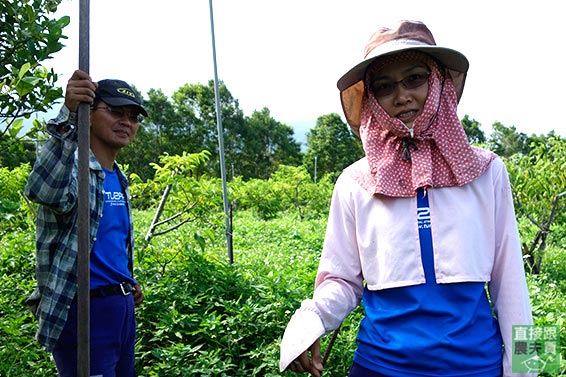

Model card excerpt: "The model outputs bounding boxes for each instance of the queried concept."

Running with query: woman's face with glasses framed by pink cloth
[370,60,430,128]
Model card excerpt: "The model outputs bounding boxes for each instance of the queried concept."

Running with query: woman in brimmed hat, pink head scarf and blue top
[280,21,532,377]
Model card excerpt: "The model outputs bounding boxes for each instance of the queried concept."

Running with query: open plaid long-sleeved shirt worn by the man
[25,106,134,352]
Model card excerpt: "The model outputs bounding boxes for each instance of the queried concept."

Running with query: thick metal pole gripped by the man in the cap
[77,0,90,377]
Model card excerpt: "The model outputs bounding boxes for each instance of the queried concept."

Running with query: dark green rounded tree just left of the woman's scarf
[303,113,364,178]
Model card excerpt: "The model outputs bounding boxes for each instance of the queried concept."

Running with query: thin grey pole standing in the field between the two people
[208,0,234,264]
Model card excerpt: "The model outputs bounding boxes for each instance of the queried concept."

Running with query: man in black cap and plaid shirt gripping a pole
[25,70,147,377]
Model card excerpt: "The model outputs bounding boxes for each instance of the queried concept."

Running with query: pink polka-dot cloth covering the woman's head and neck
[350,51,496,197]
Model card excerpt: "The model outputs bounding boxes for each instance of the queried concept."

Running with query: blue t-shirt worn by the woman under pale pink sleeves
[354,189,502,377]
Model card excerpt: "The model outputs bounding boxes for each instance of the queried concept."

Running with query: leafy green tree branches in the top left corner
[0,0,70,165]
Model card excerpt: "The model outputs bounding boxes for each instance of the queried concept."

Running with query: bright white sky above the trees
[43,0,566,141]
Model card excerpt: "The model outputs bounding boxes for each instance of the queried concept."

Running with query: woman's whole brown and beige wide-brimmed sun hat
[337,21,469,135]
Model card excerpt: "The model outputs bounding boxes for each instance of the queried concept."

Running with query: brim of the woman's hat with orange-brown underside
[337,43,469,135]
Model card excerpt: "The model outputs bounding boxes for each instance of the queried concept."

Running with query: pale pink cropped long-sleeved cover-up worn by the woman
[281,155,532,376]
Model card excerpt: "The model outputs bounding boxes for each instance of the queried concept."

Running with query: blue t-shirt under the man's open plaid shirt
[90,169,135,289]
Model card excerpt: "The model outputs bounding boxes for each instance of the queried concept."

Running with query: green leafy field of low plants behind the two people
[0,207,566,377]
